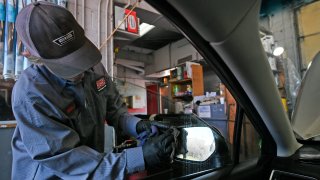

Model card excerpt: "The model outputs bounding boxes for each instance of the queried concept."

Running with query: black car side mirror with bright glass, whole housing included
[150,114,231,171]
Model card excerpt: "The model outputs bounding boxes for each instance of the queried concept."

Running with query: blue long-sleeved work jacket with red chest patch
[12,63,144,180]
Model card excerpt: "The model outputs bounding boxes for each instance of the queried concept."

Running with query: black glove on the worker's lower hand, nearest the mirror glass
[142,130,174,168]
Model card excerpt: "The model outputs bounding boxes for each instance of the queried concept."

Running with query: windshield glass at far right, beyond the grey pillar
[260,1,320,140]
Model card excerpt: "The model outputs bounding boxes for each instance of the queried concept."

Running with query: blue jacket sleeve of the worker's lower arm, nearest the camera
[13,101,144,179]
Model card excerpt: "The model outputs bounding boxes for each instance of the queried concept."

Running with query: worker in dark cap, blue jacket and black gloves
[12,1,174,180]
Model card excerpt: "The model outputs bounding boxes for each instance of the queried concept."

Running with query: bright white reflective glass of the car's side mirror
[176,127,215,161]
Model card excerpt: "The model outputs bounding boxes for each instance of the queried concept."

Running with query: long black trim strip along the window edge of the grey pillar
[146,0,276,156]
